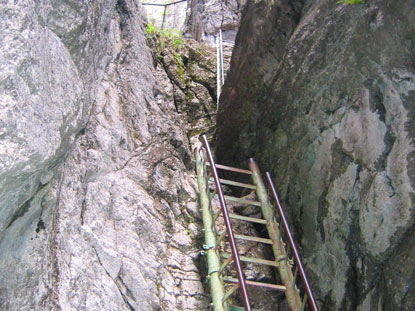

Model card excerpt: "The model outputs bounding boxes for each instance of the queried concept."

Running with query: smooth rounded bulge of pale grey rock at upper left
[0,2,85,238]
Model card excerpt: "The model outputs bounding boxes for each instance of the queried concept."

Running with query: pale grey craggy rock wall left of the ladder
[0,0,207,310]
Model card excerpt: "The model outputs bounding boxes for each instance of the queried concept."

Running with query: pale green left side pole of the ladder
[195,149,228,311]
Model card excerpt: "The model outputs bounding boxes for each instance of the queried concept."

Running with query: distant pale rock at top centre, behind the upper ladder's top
[184,0,247,43]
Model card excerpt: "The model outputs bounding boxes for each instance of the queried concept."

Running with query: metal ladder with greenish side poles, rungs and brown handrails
[195,135,318,311]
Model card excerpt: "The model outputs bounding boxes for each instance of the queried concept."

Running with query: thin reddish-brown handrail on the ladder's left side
[202,135,252,311]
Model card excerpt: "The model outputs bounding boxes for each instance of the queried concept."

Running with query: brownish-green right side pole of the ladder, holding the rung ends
[249,159,301,311]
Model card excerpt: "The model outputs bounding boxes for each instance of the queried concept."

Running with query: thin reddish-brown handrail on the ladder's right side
[266,172,318,311]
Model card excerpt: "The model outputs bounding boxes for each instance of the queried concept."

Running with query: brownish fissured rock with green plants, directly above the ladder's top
[148,28,226,142]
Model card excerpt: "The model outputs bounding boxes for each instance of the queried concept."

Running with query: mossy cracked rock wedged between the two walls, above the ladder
[153,39,217,132]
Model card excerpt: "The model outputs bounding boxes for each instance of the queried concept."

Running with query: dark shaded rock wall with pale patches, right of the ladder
[216,0,415,311]
